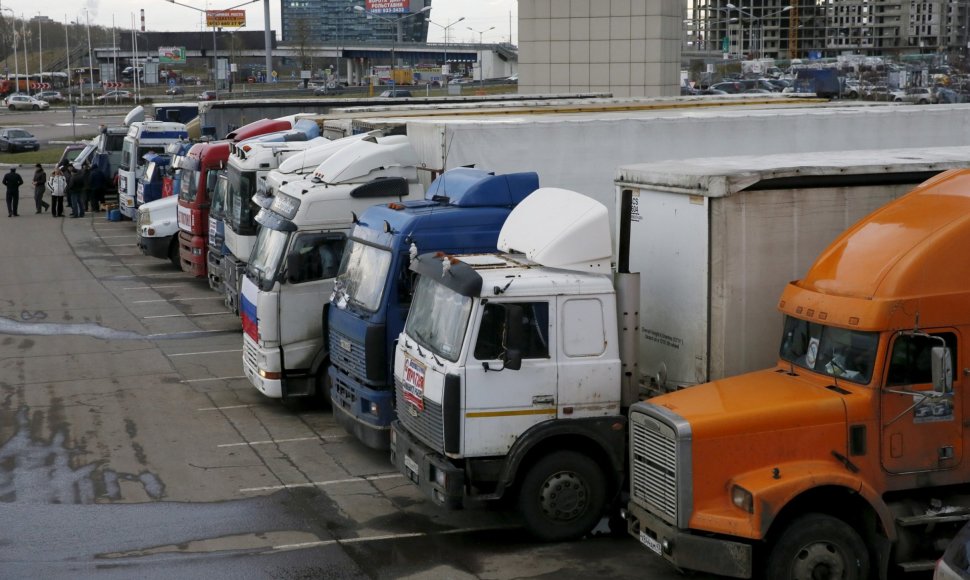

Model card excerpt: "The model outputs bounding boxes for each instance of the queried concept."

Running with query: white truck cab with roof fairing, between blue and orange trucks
[391,188,625,540]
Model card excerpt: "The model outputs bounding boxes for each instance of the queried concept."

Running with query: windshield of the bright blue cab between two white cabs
[334,239,391,312]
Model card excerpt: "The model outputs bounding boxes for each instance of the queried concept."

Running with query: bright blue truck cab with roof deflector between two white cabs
[324,168,539,449]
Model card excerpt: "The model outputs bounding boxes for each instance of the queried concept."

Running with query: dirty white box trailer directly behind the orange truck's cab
[616,147,970,391]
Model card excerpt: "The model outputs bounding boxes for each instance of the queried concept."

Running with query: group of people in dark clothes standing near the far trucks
[3,163,108,218]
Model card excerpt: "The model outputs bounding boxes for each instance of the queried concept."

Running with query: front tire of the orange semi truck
[765,514,869,580]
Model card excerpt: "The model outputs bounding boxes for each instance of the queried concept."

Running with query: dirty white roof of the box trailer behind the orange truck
[615,147,970,197]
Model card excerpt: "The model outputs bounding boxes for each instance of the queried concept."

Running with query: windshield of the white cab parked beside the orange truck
[404,276,472,362]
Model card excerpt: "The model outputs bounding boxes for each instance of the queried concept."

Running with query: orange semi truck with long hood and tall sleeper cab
[626,170,970,580]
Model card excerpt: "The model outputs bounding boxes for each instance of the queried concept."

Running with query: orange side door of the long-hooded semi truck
[881,330,963,473]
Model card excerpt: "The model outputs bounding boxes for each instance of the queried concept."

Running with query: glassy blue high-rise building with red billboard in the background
[280,0,431,44]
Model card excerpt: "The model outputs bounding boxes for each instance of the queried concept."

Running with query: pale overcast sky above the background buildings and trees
[0,0,518,42]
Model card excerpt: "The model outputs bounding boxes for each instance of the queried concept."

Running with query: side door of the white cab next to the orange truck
[462,301,558,456]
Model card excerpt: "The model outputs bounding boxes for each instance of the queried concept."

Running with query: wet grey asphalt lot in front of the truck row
[0,198,702,580]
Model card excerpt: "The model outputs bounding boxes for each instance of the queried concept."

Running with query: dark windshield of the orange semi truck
[780,316,879,384]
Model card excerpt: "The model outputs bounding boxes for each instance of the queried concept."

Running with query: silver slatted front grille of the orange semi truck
[630,414,678,525]
